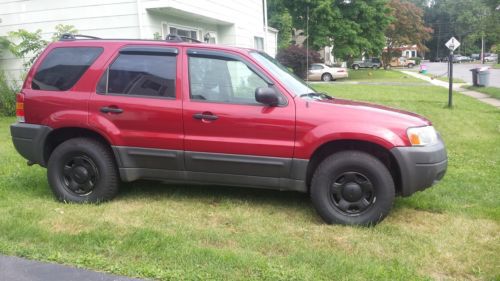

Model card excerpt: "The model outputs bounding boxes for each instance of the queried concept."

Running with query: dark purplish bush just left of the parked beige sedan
[276,45,321,78]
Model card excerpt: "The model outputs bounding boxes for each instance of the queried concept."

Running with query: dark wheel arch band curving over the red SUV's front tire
[306,139,402,194]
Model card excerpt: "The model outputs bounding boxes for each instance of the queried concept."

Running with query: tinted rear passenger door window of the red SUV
[97,53,177,98]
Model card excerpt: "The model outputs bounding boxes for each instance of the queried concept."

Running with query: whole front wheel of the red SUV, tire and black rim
[310,151,395,226]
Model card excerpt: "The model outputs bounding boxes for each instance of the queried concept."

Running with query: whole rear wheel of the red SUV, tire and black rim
[47,138,119,203]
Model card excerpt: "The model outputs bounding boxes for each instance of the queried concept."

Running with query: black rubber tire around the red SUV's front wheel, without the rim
[311,151,395,226]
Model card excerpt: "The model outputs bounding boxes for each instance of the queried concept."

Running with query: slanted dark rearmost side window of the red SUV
[31,47,102,91]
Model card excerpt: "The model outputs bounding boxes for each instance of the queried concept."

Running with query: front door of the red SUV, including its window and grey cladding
[183,50,295,177]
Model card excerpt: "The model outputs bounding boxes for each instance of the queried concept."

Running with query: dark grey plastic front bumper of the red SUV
[391,138,448,196]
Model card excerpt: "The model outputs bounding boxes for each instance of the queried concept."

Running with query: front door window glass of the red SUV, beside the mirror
[189,57,268,104]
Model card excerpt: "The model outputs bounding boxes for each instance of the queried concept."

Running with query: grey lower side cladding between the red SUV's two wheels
[113,146,308,192]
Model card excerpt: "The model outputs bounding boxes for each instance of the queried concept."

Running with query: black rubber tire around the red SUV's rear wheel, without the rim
[47,139,117,203]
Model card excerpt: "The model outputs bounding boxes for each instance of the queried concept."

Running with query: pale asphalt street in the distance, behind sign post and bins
[415,62,500,88]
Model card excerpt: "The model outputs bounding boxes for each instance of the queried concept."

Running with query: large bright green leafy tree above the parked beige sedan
[283,0,391,59]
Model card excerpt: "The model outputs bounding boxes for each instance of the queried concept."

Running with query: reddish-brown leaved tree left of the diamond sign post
[383,0,432,65]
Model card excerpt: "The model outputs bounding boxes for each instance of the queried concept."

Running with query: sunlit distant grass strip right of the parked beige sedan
[348,69,425,83]
